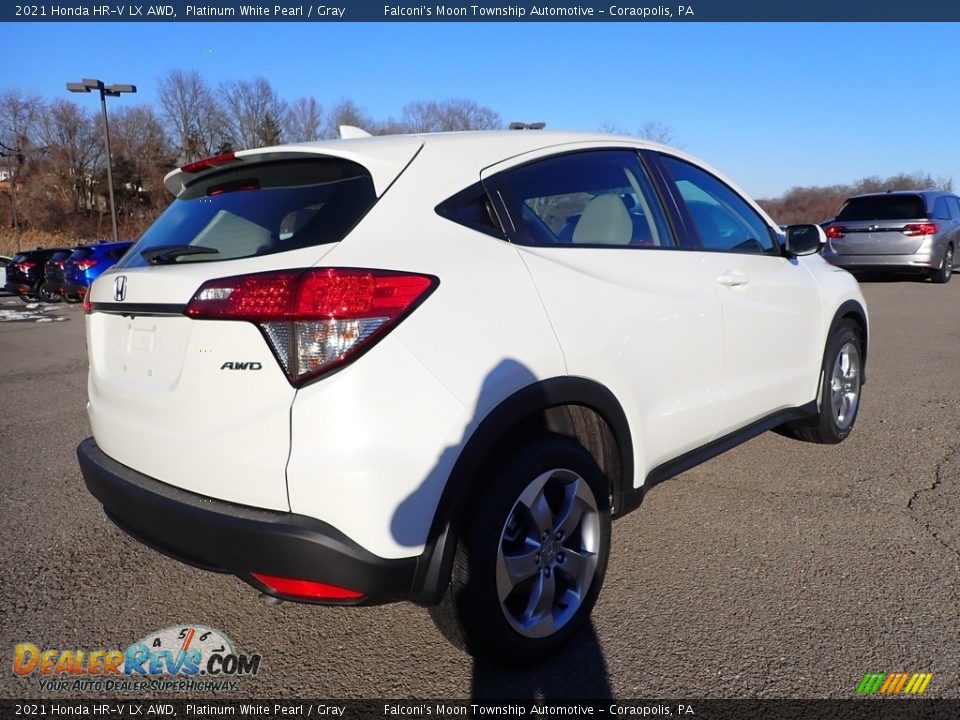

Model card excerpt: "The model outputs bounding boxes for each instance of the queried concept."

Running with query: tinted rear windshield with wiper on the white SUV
[118,158,377,267]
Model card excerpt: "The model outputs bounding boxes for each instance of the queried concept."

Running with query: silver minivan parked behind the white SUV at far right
[823,190,960,283]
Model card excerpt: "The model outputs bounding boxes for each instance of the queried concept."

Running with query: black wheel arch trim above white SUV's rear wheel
[411,377,636,605]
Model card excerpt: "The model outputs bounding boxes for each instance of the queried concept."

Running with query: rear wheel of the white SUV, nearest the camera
[430,435,610,665]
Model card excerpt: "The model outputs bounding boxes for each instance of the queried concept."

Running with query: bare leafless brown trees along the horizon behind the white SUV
[0,75,952,255]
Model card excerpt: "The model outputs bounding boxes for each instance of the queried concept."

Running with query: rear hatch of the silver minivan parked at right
[826,193,931,255]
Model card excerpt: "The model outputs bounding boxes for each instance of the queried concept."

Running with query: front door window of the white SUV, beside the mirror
[661,155,777,255]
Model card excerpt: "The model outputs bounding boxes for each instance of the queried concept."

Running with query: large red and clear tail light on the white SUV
[185,268,438,386]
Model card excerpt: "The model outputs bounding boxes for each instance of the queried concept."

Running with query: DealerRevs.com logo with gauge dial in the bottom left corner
[13,625,262,692]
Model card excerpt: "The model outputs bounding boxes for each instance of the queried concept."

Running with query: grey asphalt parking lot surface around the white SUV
[0,280,960,699]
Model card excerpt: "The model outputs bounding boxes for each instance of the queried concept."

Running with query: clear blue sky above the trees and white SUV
[0,22,960,197]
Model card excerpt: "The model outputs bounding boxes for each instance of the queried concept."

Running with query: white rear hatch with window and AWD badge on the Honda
[87,139,419,510]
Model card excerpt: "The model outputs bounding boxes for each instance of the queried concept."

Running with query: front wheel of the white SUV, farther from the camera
[784,320,863,445]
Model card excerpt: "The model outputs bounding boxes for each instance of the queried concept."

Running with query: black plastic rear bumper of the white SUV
[77,438,417,605]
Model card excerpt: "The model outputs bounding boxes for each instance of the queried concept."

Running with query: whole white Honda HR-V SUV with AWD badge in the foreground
[78,131,868,661]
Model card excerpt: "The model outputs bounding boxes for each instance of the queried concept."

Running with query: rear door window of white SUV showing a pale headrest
[497,150,676,248]
